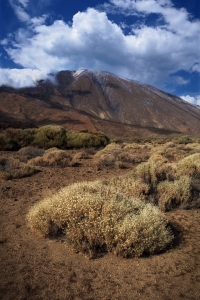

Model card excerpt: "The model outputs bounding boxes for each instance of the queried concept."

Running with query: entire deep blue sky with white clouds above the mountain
[0,0,200,105]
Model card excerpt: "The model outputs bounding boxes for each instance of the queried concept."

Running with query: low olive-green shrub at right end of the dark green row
[66,132,109,148]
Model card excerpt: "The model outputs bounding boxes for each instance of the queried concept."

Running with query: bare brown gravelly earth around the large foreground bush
[0,151,200,300]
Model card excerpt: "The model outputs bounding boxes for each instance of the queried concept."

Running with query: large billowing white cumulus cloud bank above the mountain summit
[0,0,200,105]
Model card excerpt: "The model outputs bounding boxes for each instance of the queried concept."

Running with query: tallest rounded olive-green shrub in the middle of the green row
[32,125,66,149]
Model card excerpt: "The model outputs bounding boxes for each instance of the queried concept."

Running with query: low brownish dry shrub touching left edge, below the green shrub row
[0,157,38,179]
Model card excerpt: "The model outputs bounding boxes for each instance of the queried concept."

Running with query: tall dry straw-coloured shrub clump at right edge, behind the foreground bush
[133,153,200,211]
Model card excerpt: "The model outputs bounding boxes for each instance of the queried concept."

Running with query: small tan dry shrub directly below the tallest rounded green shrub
[28,150,72,168]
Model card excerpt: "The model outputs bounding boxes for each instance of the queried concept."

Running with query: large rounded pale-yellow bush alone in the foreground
[28,181,173,257]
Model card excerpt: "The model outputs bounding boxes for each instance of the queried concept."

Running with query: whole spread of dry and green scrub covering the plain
[0,126,200,257]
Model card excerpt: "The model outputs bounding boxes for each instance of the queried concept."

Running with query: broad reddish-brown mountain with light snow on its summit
[0,70,200,136]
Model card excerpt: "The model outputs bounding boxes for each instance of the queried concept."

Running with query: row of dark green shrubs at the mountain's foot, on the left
[0,125,109,151]
